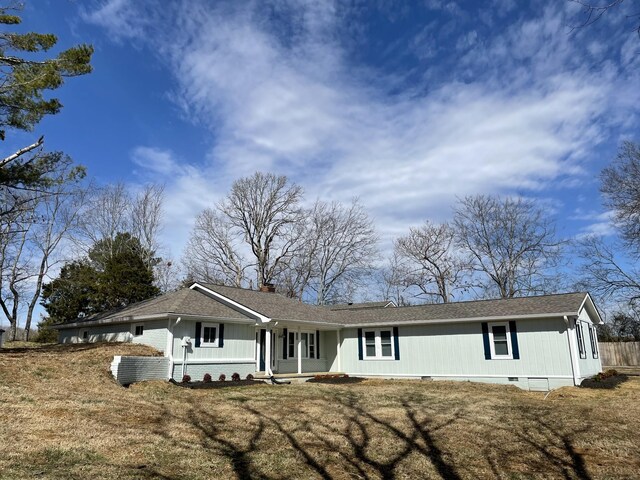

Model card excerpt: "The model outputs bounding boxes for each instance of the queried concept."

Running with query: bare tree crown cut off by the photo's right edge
[600,142,640,256]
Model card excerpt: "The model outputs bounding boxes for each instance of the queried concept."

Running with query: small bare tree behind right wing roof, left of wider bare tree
[394,221,470,303]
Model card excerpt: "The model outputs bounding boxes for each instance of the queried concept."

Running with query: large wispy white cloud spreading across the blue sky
[81,0,636,258]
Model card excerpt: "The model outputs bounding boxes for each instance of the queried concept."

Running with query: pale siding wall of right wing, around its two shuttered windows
[341,318,573,389]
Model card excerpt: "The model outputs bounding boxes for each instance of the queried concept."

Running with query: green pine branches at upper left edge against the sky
[0,7,93,219]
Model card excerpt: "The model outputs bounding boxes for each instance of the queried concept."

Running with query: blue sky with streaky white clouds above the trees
[15,0,640,258]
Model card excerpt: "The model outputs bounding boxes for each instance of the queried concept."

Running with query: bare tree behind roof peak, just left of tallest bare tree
[183,208,251,287]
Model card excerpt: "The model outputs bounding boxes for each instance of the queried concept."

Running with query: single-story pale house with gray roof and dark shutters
[56,283,601,390]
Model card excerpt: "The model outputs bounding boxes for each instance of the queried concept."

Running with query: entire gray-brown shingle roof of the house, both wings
[63,284,587,326]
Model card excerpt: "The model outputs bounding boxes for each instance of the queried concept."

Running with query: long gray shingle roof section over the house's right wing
[340,293,587,325]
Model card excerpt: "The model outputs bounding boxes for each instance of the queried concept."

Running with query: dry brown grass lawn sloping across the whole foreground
[0,344,640,480]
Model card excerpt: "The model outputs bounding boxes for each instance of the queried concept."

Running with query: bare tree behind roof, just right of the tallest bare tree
[309,200,378,305]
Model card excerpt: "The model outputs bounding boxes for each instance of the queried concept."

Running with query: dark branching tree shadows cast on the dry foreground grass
[149,393,591,480]
